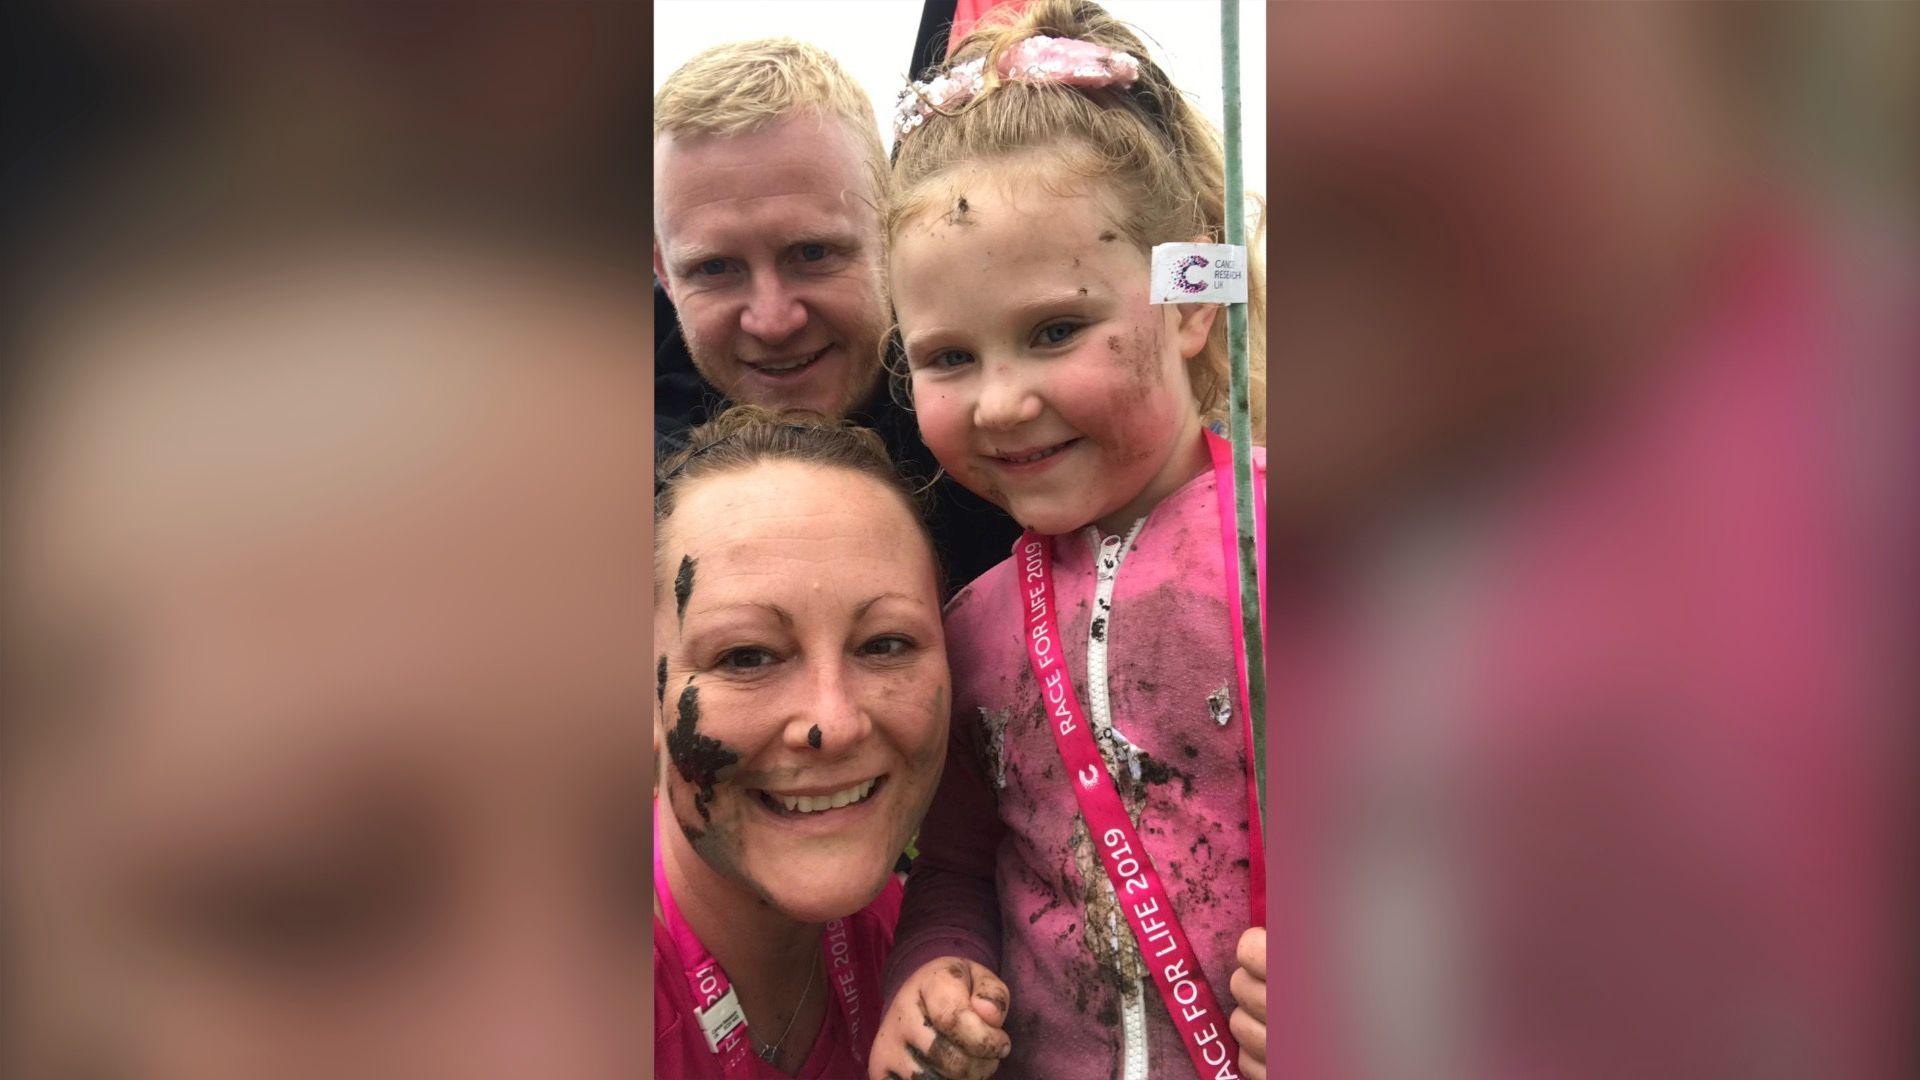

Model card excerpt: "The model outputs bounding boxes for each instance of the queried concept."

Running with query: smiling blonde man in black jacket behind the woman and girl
[653,38,1018,586]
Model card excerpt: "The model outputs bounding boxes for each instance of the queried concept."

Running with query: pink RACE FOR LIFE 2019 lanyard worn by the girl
[1016,432,1265,1080]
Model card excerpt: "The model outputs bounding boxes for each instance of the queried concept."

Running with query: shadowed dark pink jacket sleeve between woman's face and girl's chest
[883,684,1006,1001]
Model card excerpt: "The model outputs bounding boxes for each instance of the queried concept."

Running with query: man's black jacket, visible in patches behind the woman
[653,282,1020,596]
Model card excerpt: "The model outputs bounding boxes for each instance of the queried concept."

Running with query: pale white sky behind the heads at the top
[653,0,1267,194]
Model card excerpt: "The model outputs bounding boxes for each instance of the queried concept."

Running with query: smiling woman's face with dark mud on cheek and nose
[655,461,948,920]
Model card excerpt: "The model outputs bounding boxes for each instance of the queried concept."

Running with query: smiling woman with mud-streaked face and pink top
[653,407,967,1078]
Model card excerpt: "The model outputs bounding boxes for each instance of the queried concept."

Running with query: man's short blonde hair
[653,38,887,198]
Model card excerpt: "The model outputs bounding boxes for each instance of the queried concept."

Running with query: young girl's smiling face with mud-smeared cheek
[889,167,1213,532]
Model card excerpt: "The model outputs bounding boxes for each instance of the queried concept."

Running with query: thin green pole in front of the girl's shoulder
[1219,0,1267,821]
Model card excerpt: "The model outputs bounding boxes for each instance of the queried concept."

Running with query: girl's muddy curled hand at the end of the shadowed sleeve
[866,957,1014,1080]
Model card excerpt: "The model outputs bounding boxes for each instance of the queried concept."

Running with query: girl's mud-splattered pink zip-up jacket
[885,448,1265,1080]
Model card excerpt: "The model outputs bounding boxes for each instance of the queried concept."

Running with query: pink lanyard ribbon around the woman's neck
[653,803,879,1078]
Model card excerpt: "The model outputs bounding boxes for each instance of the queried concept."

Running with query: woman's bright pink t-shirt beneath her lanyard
[653,876,902,1080]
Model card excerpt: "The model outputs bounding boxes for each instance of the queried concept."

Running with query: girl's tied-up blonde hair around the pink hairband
[887,0,1267,442]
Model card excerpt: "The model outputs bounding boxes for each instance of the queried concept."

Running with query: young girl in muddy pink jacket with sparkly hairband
[870,0,1265,1080]
